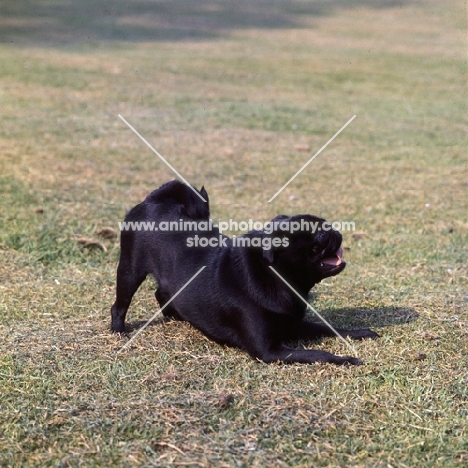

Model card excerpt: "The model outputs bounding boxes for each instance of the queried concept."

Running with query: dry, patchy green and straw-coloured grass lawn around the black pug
[0,0,468,467]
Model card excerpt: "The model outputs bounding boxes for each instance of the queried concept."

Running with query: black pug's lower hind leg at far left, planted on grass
[111,262,147,333]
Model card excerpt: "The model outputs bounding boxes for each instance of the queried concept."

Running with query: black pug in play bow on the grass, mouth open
[111,181,378,365]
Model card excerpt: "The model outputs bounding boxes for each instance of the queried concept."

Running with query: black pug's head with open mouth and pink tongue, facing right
[263,215,346,289]
